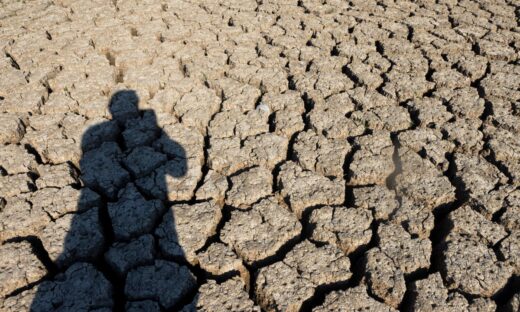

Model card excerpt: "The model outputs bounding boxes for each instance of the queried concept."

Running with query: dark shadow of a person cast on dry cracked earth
[31,90,195,311]
